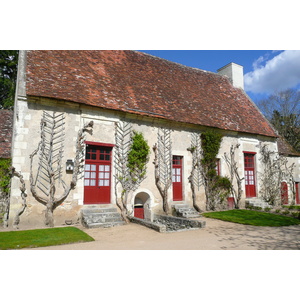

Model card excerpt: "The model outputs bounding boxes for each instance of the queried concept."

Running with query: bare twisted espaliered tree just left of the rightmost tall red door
[224,144,244,209]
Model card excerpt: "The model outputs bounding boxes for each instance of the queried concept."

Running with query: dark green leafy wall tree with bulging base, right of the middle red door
[200,130,231,210]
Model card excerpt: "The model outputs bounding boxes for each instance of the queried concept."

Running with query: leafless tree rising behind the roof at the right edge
[258,89,300,152]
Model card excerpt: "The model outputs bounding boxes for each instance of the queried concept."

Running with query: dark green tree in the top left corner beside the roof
[0,50,19,109]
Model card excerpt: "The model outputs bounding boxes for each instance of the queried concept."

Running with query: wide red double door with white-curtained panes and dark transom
[84,145,112,204]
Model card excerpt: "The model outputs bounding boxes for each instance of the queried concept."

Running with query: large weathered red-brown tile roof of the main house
[27,50,276,136]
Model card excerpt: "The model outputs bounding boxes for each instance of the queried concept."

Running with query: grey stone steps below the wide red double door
[81,205,125,228]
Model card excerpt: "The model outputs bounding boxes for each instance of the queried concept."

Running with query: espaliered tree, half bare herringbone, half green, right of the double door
[115,122,150,223]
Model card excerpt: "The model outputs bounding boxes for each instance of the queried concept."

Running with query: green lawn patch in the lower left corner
[0,227,94,250]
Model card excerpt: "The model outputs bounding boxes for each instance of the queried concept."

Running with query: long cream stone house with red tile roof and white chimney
[10,51,300,226]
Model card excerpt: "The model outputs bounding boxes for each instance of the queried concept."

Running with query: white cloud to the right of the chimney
[244,50,300,93]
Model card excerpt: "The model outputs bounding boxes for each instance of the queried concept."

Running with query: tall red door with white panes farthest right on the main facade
[244,153,256,198]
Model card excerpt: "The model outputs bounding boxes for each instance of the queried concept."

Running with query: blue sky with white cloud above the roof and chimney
[140,50,300,103]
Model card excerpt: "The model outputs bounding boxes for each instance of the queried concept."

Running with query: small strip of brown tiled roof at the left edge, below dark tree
[0,109,13,158]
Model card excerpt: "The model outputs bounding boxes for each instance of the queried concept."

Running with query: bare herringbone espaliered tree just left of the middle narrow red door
[153,128,172,215]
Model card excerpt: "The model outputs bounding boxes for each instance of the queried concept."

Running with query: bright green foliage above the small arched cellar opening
[127,131,150,182]
